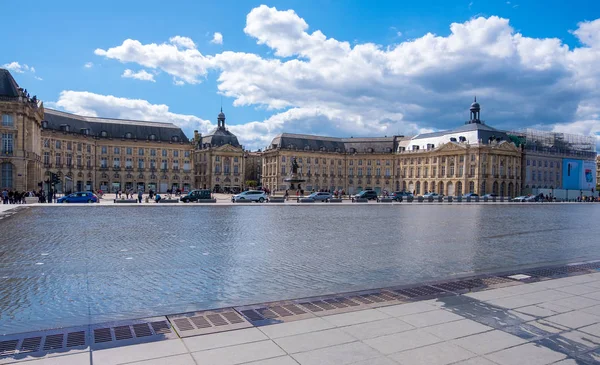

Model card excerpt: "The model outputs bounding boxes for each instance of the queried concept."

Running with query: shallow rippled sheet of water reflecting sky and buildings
[0,204,600,333]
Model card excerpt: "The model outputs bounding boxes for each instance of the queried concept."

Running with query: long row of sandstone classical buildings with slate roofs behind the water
[0,69,600,196]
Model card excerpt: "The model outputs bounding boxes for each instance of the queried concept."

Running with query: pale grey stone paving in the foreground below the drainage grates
[2,264,600,365]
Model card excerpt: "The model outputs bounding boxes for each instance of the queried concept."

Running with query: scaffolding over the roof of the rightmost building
[509,128,596,159]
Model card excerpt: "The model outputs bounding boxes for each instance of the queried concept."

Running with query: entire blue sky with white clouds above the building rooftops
[0,0,600,148]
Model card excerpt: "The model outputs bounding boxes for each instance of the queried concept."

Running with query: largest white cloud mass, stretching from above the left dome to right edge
[88,5,600,149]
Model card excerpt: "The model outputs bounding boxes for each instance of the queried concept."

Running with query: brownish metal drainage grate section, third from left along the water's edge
[167,308,252,337]
